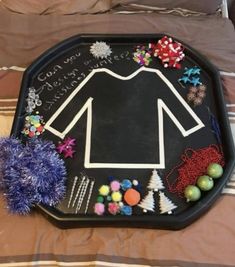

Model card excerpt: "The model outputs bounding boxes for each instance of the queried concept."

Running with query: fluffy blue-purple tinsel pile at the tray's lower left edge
[0,137,66,214]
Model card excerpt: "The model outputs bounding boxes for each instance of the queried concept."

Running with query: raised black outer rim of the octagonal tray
[11,33,235,230]
